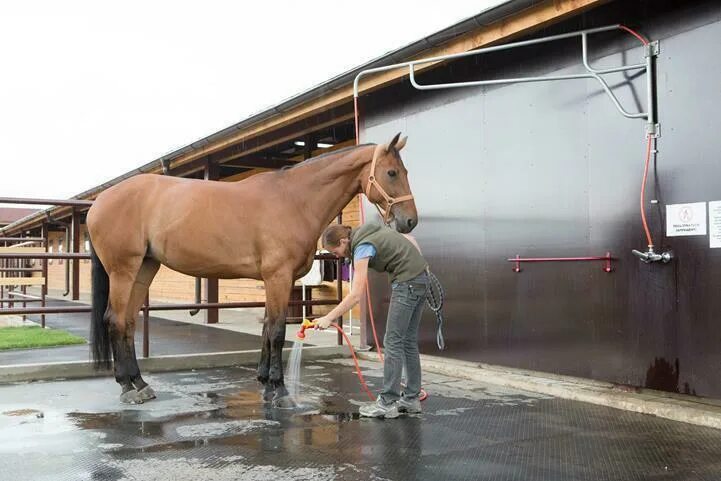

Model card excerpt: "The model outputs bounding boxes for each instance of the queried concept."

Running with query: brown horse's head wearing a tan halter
[363,132,418,233]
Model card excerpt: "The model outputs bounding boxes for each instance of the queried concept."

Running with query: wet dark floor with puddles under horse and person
[0,360,721,481]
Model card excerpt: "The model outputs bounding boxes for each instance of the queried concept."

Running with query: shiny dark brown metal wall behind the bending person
[361,1,721,397]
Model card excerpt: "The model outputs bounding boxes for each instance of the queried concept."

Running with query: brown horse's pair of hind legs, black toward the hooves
[108,258,159,404]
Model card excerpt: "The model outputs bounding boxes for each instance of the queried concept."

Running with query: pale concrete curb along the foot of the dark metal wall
[358,352,721,429]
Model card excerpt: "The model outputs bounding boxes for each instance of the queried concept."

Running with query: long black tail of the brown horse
[90,245,112,369]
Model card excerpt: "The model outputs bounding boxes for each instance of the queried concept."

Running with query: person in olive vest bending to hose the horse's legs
[316,224,428,418]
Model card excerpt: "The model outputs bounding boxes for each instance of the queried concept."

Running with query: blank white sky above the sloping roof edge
[0,0,503,202]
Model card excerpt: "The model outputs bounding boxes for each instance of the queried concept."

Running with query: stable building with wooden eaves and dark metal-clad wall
[0,0,721,397]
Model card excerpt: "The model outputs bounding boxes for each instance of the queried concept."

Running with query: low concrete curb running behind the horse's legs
[0,346,349,383]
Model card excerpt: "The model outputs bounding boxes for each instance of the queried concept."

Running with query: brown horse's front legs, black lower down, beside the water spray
[258,272,293,407]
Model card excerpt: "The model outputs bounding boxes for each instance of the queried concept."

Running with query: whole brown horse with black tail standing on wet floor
[87,134,418,406]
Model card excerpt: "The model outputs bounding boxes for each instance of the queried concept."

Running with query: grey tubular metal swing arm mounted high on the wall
[353,25,660,137]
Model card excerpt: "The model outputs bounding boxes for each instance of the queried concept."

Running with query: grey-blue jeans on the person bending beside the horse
[380,272,428,405]
